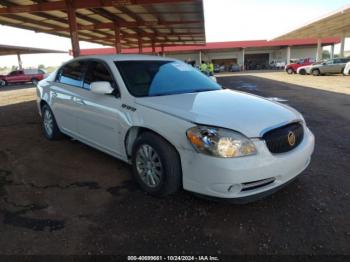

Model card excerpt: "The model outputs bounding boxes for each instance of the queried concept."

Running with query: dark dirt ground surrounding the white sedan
[0,75,350,255]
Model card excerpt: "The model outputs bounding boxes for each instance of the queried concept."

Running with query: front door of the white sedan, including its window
[72,60,124,156]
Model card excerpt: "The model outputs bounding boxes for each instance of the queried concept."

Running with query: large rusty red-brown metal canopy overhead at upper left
[0,0,205,56]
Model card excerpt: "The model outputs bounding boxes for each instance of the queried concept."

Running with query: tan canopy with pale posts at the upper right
[274,6,350,58]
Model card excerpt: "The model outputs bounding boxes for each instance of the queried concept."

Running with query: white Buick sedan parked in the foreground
[37,55,314,202]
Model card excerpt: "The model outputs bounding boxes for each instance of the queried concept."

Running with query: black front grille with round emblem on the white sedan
[263,123,304,154]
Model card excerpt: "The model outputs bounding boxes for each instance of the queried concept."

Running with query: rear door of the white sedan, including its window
[50,60,87,135]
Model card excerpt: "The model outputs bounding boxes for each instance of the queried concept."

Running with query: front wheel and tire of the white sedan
[132,132,182,196]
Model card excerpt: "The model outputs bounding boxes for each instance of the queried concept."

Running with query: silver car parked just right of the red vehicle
[311,58,350,76]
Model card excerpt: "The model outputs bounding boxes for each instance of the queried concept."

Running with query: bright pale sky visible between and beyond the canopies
[0,0,350,67]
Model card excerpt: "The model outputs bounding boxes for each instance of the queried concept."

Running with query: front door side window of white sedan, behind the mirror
[83,61,115,90]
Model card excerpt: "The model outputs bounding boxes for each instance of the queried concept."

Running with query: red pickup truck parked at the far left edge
[0,69,46,86]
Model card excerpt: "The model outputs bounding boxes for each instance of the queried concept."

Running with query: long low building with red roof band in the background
[81,38,340,69]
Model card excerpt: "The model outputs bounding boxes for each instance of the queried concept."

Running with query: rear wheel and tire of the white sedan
[41,104,62,140]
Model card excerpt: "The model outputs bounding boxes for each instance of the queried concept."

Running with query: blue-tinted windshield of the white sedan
[115,60,221,97]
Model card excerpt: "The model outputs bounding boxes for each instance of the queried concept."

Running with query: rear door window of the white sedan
[56,61,87,87]
